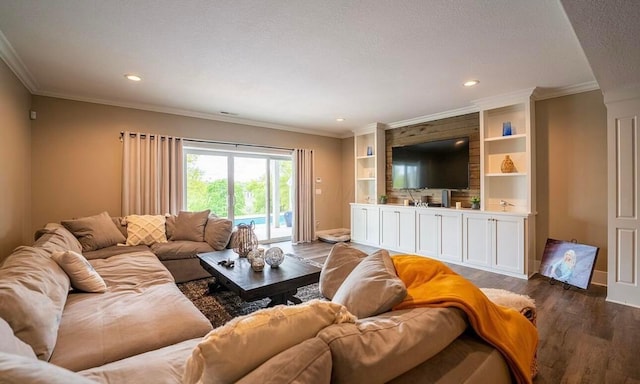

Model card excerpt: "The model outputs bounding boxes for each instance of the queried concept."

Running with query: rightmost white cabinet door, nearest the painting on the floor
[493,217,524,274]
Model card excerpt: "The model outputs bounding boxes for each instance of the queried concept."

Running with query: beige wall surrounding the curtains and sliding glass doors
[32,96,343,234]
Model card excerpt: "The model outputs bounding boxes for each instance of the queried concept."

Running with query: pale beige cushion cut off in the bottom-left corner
[0,352,95,384]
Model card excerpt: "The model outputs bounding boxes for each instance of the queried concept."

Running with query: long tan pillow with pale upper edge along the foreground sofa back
[183,300,355,384]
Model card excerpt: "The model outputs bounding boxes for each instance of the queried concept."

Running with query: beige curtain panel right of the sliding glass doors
[291,149,316,244]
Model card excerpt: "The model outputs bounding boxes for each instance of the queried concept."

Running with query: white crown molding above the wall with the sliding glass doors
[34,92,349,138]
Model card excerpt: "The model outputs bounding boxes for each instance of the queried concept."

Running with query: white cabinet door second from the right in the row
[463,215,493,267]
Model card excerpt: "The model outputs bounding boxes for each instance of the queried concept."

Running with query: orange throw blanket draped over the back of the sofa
[392,255,538,383]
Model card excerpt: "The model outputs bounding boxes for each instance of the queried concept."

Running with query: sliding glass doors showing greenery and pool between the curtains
[184,142,293,243]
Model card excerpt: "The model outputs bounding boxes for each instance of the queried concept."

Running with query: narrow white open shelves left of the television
[353,123,385,204]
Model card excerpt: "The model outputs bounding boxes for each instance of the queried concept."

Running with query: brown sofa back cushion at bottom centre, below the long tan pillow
[236,337,331,384]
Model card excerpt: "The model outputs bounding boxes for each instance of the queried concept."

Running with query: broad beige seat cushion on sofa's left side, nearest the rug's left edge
[50,282,212,371]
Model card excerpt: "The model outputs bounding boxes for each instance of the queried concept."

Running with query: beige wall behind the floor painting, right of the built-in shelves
[536,90,607,271]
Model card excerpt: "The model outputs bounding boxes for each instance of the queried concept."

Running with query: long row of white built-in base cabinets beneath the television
[351,204,533,278]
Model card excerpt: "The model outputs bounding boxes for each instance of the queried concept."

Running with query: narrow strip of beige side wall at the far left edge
[0,60,31,260]
